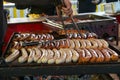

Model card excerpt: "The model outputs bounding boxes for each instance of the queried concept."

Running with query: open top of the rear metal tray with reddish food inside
[48,14,115,25]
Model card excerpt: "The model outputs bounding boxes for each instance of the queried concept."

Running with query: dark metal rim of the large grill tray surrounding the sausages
[2,33,120,67]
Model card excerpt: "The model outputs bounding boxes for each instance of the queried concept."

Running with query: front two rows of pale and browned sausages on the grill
[5,32,118,64]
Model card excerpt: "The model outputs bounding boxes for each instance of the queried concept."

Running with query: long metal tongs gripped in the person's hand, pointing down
[54,0,80,33]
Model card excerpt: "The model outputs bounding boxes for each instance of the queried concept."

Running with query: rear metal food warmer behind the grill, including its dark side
[48,14,117,38]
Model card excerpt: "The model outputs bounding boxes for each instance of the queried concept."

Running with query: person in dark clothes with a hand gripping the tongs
[13,0,73,16]
